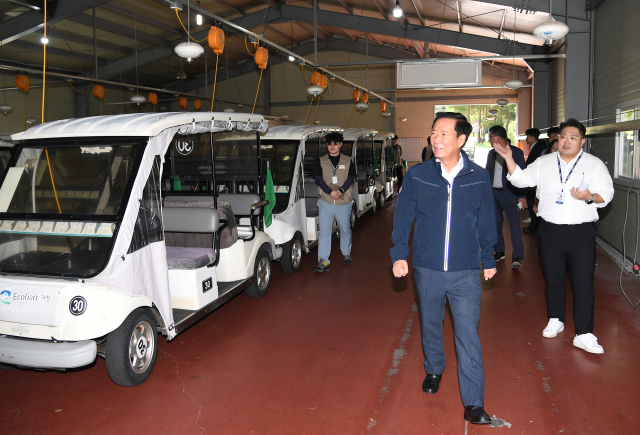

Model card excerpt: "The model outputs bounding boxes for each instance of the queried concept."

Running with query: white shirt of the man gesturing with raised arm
[507,151,613,225]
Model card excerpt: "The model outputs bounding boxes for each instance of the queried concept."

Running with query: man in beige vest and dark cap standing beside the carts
[313,132,356,272]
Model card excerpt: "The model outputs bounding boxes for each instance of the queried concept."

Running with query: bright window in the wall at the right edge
[615,102,640,180]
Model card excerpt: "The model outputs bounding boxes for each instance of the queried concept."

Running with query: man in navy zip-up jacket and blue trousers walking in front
[391,112,497,424]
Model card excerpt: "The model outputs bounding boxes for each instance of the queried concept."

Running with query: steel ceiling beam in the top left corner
[0,0,109,45]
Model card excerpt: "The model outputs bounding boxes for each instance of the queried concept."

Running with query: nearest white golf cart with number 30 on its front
[0,112,275,386]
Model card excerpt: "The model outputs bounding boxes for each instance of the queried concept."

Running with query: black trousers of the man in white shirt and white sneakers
[538,219,596,334]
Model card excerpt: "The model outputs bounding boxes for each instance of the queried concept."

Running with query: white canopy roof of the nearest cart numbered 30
[11,112,266,141]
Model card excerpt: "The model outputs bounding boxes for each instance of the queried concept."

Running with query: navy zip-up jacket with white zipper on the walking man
[390,152,497,271]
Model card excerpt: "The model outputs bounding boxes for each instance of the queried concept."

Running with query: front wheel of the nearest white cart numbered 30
[105,308,158,387]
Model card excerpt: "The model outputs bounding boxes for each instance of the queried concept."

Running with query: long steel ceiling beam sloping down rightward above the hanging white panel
[278,5,546,56]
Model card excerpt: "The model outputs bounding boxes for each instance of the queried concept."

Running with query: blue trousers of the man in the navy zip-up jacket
[413,265,484,407]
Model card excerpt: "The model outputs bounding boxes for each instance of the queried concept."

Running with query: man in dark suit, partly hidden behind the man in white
[485,125,527,268]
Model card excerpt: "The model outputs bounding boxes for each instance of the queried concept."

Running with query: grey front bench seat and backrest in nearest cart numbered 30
[163,207,220,270]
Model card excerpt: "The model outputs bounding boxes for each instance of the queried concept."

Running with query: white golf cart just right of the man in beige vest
[341,128,384,217]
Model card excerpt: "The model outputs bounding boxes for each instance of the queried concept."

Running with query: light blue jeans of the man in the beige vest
[318,199,352,264]
